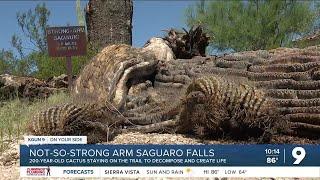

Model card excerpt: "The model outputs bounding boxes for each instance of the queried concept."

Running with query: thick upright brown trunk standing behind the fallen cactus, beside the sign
[86,0,133,49]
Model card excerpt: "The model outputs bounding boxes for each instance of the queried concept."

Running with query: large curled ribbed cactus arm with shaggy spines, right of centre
[177,75,280,141]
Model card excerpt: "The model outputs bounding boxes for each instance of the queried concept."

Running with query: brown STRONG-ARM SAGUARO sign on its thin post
[46,26,87,90]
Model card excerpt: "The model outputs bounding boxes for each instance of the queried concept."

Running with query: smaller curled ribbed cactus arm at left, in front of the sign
[28,103,123,143]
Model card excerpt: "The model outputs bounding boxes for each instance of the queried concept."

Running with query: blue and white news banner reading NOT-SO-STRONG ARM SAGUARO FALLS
[20,144,320,177]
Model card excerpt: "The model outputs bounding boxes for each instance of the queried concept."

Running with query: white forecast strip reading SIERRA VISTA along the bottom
[20,166,320,178]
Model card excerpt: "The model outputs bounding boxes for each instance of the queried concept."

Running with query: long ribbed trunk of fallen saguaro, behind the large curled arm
[136,44,320,138]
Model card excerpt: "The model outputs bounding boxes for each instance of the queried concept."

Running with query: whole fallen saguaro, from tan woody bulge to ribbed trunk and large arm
[26,42,320,142]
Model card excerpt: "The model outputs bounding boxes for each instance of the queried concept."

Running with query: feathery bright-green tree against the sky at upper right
[186,0,317,51]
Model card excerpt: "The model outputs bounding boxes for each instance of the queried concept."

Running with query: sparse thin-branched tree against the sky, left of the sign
[11,3,50,76]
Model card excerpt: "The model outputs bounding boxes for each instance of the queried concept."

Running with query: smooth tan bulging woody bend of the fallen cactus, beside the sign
[73,45,158,109]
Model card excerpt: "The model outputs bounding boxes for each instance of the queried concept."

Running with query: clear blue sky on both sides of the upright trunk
[0,0,195,54]
